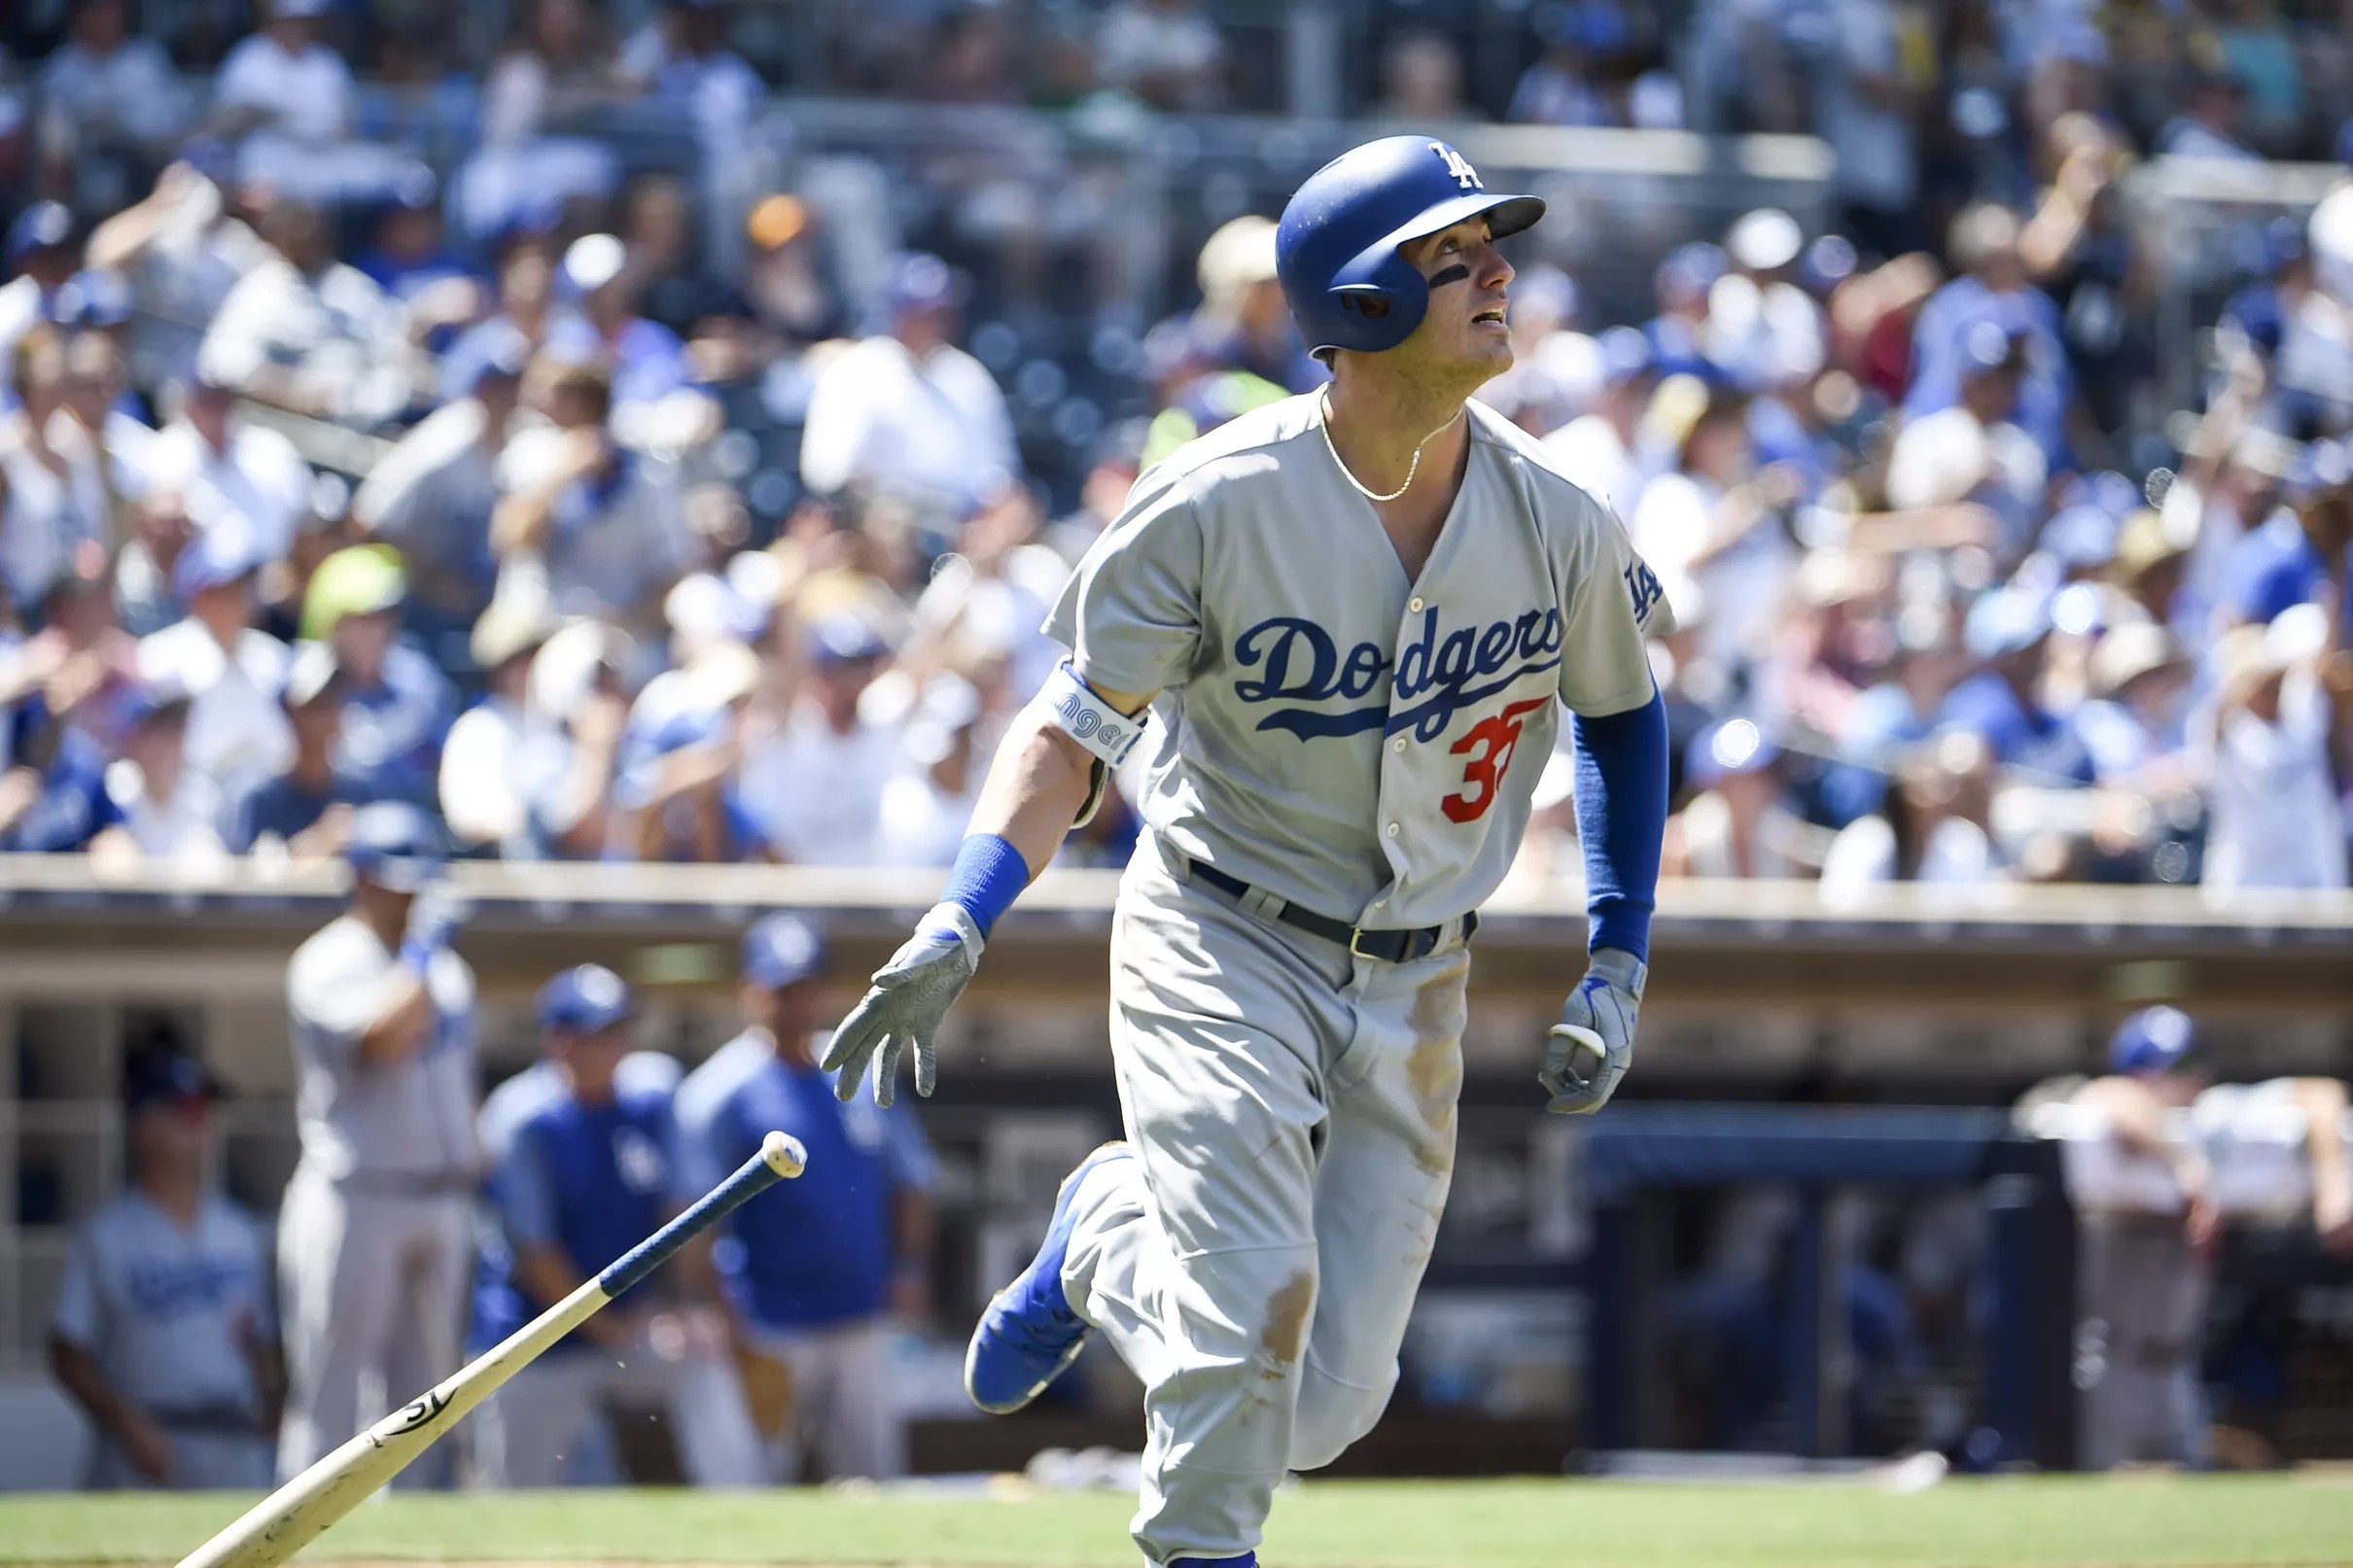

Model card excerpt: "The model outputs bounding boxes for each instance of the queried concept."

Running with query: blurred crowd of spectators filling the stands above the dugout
[0,0,2353,895]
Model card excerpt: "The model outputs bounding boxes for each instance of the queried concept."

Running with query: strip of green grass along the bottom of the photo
[0,1474,2353,1568]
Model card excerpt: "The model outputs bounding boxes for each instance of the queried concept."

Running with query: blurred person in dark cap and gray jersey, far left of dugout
[50,1049,285,1490]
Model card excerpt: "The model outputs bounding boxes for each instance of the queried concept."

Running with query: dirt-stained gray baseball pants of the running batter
[1064,839,1471,1563]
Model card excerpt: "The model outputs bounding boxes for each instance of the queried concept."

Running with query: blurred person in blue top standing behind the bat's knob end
[676,915,931,1481]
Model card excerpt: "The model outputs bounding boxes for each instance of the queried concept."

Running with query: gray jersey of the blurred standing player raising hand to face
[287,915,477,1180]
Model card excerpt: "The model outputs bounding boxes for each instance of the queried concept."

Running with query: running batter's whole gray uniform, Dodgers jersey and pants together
[1047,398,1670,1563]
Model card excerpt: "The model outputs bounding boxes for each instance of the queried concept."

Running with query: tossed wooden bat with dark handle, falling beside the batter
[179,1133,807,1568]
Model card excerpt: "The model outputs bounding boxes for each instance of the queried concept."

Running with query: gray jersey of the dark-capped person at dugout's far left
[50,1192,278,1432]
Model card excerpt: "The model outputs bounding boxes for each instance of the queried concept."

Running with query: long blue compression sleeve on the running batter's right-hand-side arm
[1572,691,1666,963]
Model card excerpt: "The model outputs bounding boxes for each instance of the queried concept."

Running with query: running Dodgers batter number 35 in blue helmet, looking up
[825,136,1670,1563]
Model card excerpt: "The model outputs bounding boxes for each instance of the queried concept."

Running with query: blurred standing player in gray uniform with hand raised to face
[278,802,477,1477]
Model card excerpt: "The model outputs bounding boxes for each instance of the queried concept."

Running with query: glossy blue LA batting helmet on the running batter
[1276,136,1544,355]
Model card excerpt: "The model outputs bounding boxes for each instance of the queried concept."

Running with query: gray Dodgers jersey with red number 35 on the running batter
[1044,395,1670,926]
